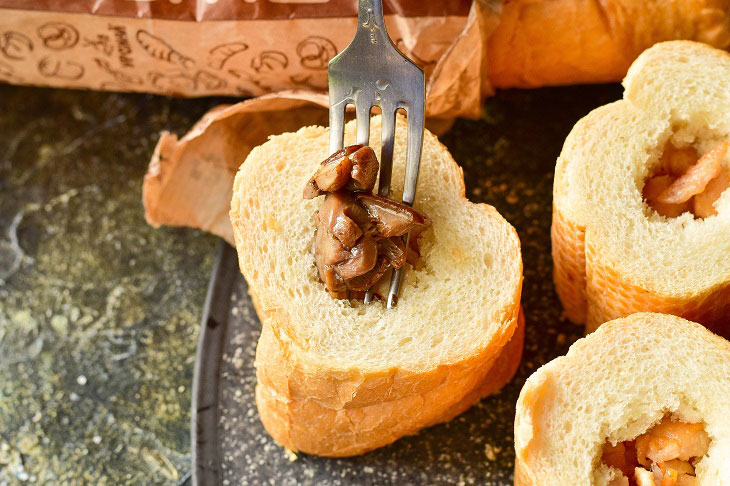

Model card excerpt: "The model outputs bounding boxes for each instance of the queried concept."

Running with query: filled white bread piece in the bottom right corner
[515,313,730,486]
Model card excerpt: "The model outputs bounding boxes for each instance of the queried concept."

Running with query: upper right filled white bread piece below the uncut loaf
[552,41,730,333]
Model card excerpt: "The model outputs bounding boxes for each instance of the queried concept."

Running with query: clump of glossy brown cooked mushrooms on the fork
[304,145,431,299]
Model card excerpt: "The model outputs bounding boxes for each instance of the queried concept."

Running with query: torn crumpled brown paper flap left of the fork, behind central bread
[142,91,328,243]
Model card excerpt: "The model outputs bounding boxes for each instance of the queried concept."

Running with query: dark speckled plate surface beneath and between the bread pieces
[208,85,621,486]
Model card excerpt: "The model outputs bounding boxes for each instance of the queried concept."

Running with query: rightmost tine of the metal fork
[387,105,424,309]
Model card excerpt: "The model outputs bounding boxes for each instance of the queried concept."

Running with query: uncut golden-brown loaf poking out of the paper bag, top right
[487,0,730,88]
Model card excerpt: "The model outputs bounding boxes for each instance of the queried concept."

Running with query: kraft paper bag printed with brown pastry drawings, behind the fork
[0,0,481,107]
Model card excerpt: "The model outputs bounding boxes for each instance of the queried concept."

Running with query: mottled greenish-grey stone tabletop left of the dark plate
[0,85,230,485]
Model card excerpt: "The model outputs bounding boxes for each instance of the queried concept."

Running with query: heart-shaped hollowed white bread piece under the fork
[230,117,522,456]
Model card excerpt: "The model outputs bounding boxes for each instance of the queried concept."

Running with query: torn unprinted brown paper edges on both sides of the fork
[143,2,499,243]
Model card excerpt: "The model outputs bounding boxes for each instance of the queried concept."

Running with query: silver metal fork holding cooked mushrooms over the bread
[328,0,426,309]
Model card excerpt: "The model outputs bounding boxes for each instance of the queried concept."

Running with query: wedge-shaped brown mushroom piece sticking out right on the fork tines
[357,194,431,238]
